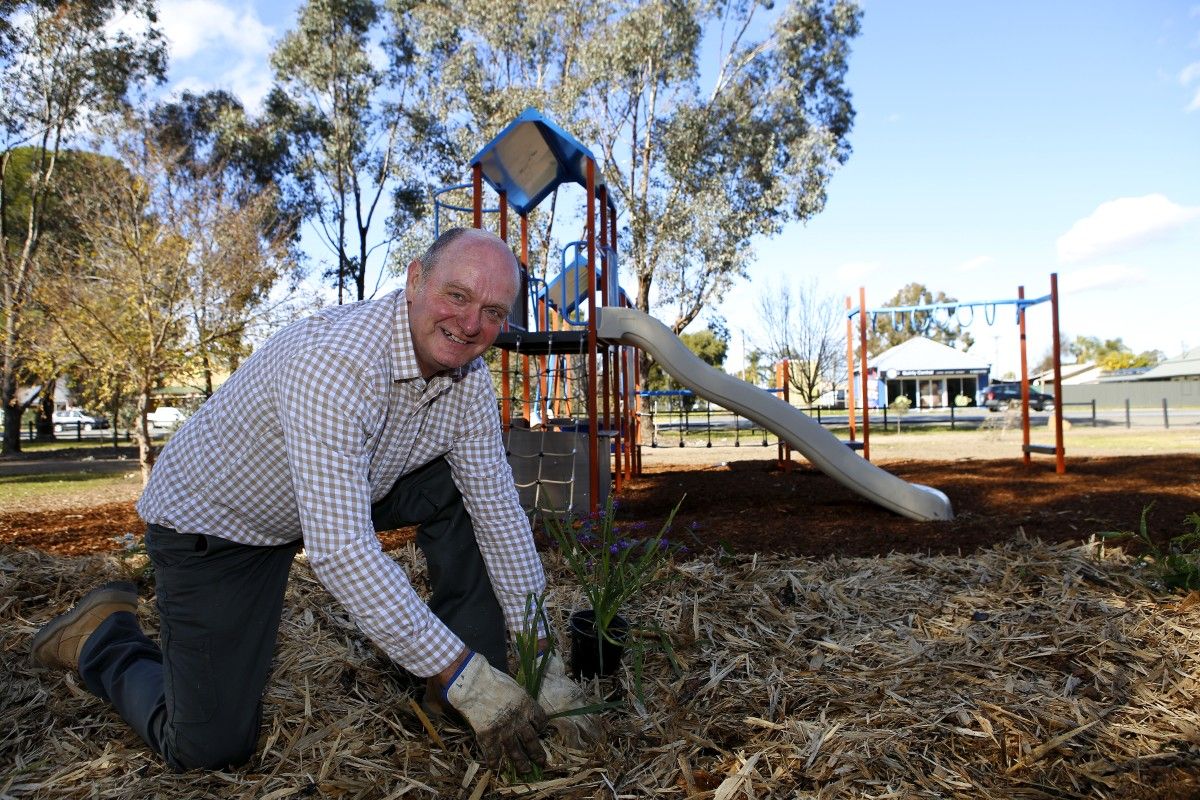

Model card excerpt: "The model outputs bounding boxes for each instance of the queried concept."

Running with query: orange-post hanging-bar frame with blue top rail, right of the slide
[846,281,1067,475]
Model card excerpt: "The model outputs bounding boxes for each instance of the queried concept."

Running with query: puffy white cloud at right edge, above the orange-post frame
[1057,194,1200,264]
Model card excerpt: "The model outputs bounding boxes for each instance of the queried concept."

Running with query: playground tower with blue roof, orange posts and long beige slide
[434,109,953,519]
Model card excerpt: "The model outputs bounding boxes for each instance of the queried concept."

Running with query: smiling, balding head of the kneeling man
[404,230,517,380]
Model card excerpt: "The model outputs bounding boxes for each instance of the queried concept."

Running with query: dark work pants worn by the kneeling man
[79,458,506,771]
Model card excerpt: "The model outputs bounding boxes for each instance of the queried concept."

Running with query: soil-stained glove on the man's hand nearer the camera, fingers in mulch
[443,652,546,775]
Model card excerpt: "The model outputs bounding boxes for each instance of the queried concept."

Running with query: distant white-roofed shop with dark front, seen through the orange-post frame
[868,337,991,409]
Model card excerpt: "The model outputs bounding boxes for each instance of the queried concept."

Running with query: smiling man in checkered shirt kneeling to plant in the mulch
[32,228,600,772]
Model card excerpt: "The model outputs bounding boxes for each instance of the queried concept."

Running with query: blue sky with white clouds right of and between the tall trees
[152,0,1200,373]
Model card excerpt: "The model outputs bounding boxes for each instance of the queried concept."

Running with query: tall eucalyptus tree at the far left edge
[0,0,166,453]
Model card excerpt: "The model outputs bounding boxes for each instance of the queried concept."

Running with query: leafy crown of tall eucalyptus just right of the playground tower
[586,0,859,332]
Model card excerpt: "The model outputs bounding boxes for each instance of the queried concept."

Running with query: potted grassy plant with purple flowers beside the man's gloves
[545,497,684,671]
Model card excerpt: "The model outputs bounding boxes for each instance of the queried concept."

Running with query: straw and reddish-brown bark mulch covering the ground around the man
[0,456,1200,800]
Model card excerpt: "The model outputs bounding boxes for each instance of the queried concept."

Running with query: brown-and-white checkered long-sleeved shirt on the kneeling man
[138,290,545,676]
